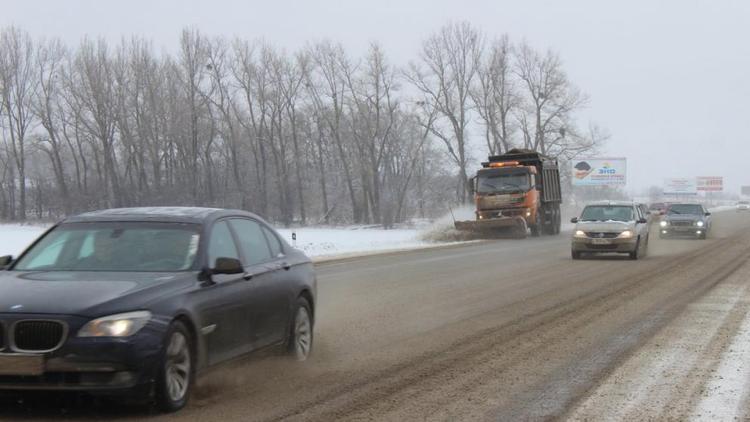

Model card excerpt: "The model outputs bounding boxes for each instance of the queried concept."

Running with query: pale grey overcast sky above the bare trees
[0,0,750,195]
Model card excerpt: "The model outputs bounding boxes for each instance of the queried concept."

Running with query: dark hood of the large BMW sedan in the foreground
[0,271,195,317]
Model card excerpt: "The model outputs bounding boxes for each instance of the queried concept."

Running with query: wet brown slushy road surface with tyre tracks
[0,211,750,421]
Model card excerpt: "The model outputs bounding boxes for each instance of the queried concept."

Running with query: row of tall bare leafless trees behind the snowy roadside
[0,23,604,226]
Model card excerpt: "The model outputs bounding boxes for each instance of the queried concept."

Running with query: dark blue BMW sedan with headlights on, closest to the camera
[0,208,316,411]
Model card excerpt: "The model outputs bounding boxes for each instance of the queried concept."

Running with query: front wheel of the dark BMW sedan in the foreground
[156,321,196,413]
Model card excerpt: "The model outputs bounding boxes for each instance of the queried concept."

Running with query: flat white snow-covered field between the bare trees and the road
[0,224,444,258]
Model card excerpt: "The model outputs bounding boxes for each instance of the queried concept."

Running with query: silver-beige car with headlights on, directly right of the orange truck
[571,201,650,259]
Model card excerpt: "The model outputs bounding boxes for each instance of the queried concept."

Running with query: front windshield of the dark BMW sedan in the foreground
[13,222,199,272]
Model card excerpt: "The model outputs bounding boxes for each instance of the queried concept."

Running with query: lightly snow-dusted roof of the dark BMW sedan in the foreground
[64,207,258,224]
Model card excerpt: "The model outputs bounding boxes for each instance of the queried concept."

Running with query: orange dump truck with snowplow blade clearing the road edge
[455,149,562,237]
